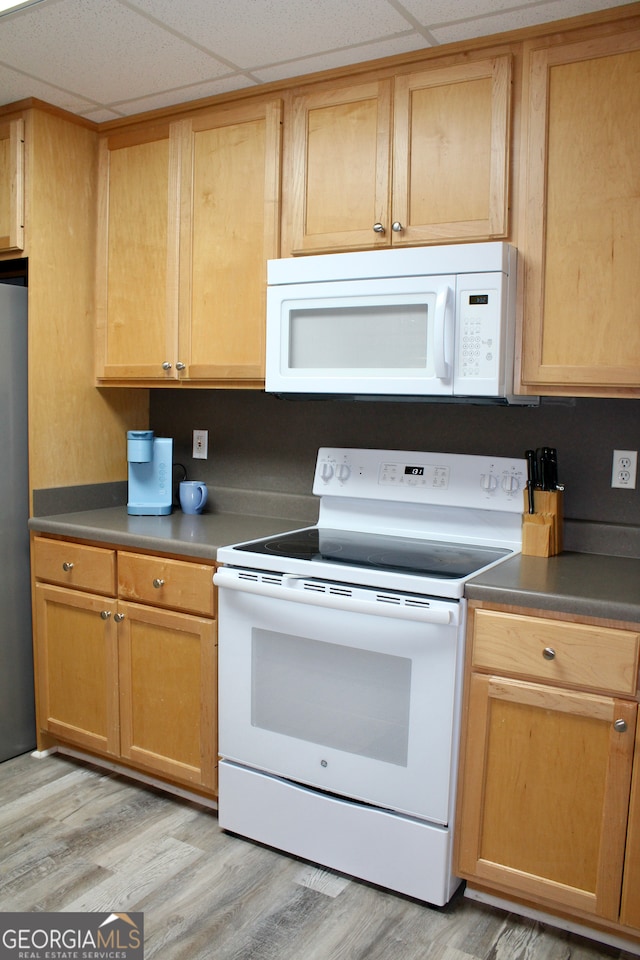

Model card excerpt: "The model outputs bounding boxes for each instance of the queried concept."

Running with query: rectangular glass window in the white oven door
[251,628,411,767]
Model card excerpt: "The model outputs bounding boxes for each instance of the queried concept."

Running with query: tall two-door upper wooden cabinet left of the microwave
[96,102,281,386]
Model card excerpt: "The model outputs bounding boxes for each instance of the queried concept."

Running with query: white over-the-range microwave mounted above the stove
[265,242,537,404]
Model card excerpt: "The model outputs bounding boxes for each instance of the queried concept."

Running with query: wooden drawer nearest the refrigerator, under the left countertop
[33,537,116,597]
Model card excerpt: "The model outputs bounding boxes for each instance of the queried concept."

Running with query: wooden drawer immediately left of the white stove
[118,553,215,617]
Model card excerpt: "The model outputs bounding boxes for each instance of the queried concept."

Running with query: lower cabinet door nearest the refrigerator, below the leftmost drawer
[35,583,119,755]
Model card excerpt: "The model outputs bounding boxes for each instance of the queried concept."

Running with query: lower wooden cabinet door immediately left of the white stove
[119,601,217,790]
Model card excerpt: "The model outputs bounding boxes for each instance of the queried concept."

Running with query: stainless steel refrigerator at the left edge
[0,283,35,761]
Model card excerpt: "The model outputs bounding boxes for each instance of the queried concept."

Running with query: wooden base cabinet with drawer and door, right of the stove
[456,604,640,929]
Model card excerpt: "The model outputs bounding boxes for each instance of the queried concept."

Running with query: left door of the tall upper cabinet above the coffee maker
[96,124,179,381]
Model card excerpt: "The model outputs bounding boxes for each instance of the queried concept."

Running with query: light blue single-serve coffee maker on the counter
[127,430,173,517]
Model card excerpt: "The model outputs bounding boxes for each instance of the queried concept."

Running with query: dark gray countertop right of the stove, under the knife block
[465,553,640,623]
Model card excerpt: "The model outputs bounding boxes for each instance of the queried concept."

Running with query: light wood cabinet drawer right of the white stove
[472,609,640,696]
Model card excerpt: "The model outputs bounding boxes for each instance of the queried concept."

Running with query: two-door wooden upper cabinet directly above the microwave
[290,55,511,254]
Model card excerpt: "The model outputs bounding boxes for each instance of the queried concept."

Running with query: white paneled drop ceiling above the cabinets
[0,0,622,123]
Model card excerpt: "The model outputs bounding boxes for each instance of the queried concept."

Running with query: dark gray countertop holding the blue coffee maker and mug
[29,507,309,560]
